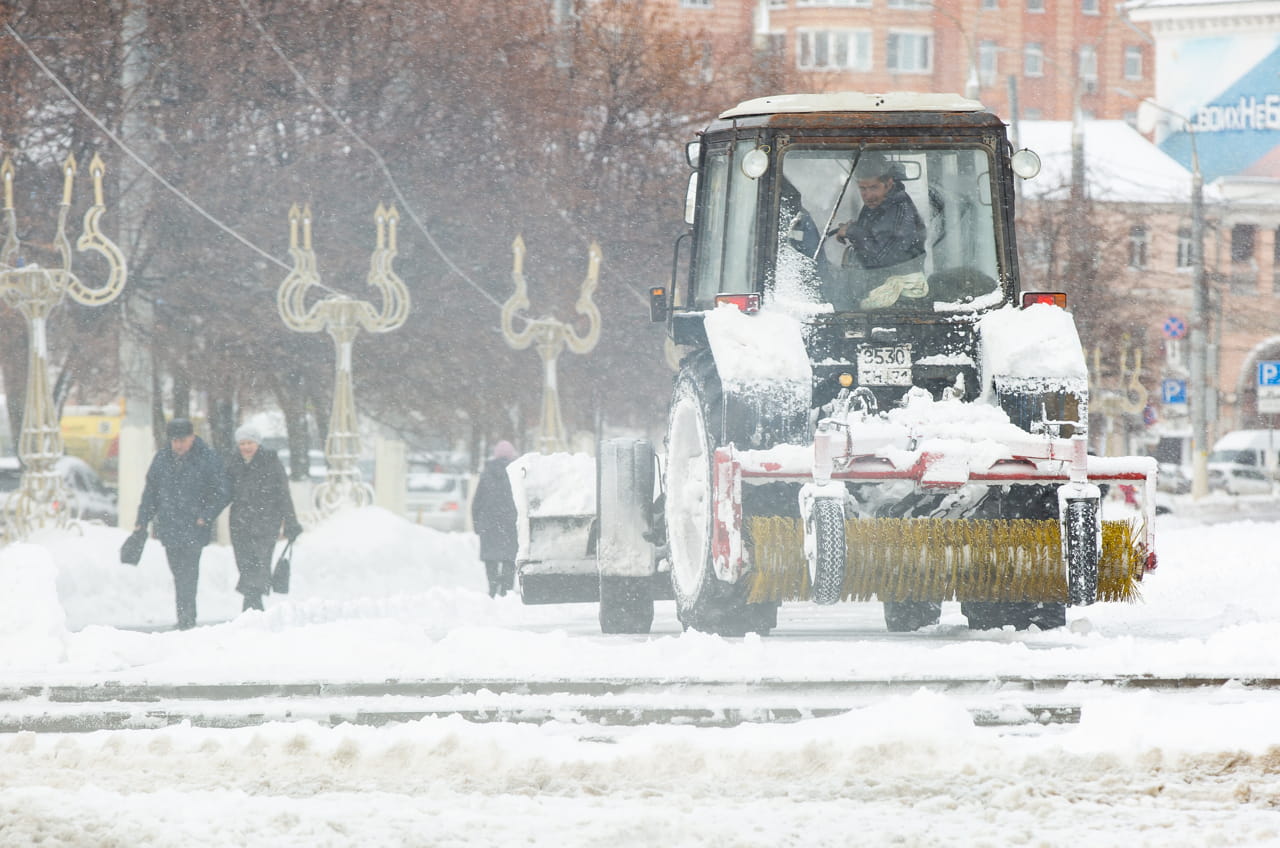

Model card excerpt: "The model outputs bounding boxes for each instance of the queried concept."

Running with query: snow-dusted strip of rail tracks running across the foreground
[0,675,1280,733]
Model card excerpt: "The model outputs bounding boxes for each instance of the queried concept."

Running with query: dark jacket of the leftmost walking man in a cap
[138,436,230,547]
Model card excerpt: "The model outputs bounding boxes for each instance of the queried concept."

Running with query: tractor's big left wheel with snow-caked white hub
[666,370,767,635]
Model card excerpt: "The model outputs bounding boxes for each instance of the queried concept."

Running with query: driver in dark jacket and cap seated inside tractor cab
[833,152,929,309]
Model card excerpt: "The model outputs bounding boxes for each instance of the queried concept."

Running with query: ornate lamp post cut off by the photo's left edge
[0,155,128,539]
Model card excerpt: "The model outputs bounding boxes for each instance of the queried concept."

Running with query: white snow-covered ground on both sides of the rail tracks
[0,500,1280,847]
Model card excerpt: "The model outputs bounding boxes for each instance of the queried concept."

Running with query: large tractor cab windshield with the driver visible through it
[773,145,1004,311]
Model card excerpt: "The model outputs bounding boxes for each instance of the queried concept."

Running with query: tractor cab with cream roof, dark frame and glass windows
[662,94,1034,333]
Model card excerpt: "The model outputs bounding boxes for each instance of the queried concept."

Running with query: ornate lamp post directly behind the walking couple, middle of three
[276,204,408,515]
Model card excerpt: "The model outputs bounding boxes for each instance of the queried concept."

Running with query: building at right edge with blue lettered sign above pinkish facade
[1130,0,1280,433]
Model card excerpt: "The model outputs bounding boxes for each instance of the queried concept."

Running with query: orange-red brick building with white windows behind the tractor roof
[662,0,1153,120]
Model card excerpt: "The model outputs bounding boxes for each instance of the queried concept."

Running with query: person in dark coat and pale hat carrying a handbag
[229,424,302,610]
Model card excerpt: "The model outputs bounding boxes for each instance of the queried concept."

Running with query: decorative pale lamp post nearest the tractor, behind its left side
[502,236,600,453]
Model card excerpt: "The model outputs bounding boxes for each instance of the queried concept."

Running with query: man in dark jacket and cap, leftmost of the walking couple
[137,418,230,630]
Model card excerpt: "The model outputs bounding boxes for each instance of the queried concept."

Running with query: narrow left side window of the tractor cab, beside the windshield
[692,140,760,309]
